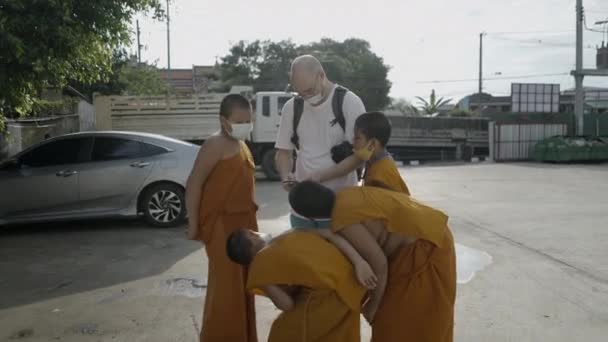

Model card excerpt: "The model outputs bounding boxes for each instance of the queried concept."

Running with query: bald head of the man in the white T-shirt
[291,55,327,99]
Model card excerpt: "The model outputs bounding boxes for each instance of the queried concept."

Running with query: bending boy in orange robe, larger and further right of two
[289,182,456,342]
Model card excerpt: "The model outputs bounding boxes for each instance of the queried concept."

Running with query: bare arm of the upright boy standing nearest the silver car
[186,138,222,239]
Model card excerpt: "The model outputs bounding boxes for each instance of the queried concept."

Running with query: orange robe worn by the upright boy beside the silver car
[198,143,257,342]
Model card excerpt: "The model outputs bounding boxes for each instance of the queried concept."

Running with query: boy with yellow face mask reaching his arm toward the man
[312,112,410,195]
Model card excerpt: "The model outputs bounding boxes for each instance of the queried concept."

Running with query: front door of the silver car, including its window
[0,137,92,220]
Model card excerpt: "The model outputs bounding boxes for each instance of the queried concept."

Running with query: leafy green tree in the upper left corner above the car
[0,0,163,126]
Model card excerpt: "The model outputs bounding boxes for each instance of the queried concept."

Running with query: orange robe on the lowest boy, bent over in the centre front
[247,231,365,342]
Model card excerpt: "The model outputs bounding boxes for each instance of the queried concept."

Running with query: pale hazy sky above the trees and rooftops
[133,0,608,101]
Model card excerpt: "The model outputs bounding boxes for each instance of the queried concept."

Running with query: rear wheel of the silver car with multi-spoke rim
[141,183,186,227]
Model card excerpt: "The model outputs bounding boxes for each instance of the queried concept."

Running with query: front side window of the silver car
[19,138,92,167]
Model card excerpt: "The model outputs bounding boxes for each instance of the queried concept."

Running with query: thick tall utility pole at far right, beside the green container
[574,0,585,135]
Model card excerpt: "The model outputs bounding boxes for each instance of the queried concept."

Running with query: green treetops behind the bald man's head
[218,39,391,110]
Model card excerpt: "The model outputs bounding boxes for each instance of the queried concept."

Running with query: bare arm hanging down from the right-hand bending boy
[340,224,388,321]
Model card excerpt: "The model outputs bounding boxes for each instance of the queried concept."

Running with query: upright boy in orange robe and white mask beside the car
[186,94,258,342]
